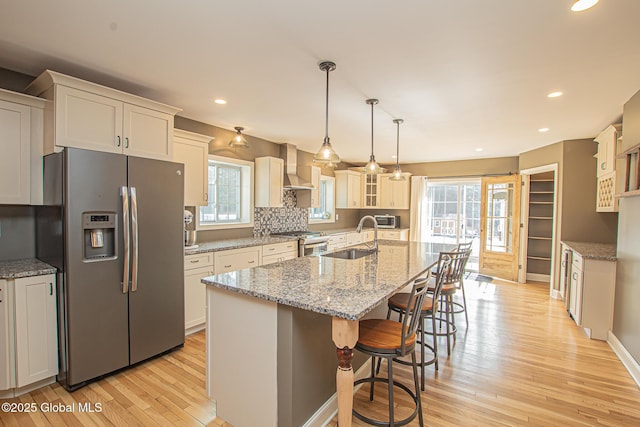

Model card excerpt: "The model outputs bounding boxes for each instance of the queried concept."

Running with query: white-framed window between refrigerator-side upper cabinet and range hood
[198,156,253,230]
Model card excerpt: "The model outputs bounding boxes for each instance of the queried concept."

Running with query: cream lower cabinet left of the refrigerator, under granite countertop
[0,274,58,397]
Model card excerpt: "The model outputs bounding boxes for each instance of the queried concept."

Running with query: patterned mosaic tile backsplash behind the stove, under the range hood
[253,190,309,236]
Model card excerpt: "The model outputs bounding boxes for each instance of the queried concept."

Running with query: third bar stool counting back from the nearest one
[425,249,471,355]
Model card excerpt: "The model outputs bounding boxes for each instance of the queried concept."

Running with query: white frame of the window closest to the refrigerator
[194,154,255,230]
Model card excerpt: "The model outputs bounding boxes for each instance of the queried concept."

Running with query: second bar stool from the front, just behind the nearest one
[378,252,454,391]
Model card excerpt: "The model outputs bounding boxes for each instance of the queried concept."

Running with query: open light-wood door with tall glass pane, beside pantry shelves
[479,175,520,281]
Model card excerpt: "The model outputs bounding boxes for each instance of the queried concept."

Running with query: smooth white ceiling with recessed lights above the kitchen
[0,0,640,163]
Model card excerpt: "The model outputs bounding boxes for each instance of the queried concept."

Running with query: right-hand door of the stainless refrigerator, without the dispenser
[128,157,184,364]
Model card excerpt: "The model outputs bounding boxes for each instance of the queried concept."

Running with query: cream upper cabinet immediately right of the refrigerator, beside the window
[173,129,213,206]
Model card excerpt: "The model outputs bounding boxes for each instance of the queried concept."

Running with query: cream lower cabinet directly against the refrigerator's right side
[184,253,213,335]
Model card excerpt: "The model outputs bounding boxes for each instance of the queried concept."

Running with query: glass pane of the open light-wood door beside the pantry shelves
[485,183,514,253]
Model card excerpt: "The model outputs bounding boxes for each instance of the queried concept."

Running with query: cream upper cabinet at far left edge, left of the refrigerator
[0,89,45,205]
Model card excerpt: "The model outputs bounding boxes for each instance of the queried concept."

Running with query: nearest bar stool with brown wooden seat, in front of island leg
[353,260,450,426]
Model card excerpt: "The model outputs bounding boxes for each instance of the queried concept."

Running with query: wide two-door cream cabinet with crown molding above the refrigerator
[27,70,180,160]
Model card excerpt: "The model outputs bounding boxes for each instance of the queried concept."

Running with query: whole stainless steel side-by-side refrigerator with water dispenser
[36,148,184,390]
